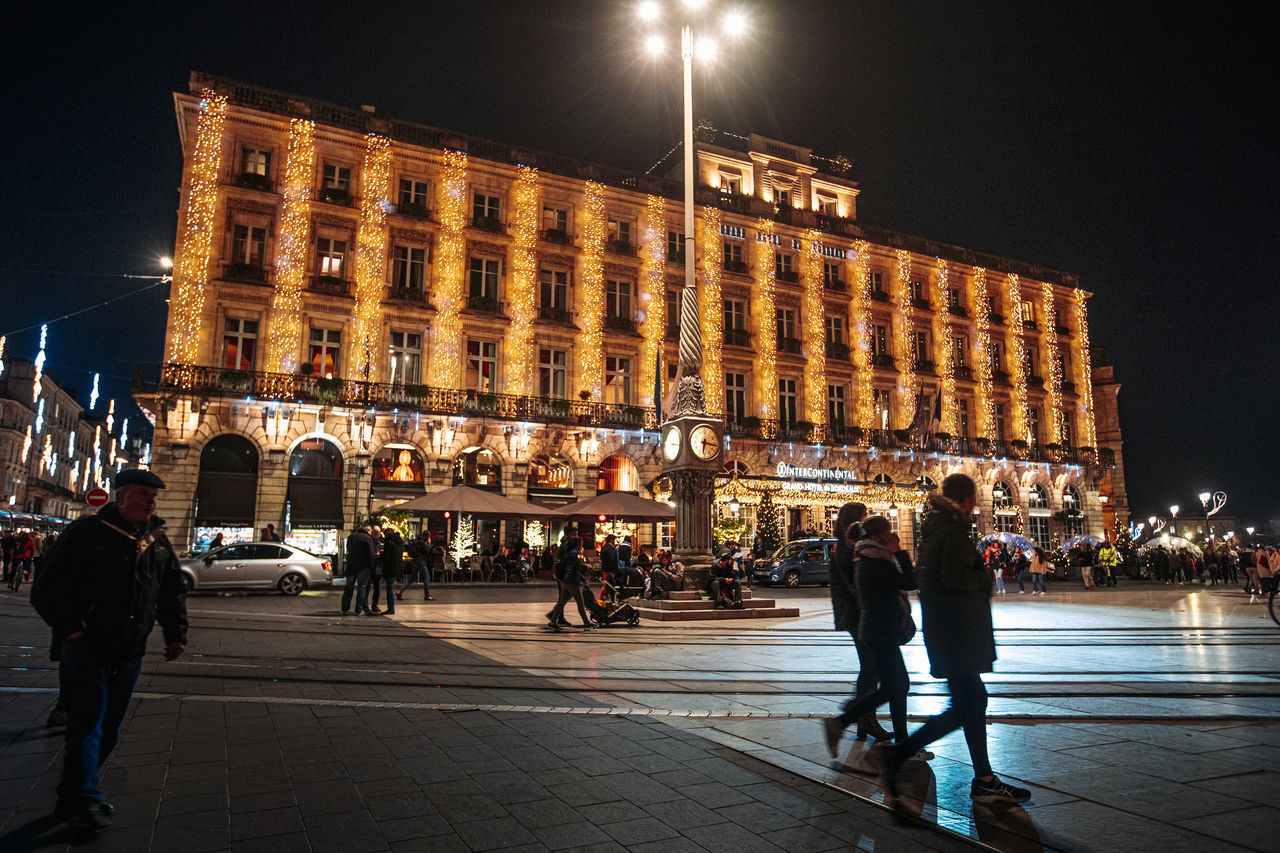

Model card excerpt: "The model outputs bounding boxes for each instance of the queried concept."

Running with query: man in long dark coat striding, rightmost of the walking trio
[884,474,1032,803]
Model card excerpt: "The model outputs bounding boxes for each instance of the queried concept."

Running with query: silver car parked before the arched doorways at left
[182,542,333,596]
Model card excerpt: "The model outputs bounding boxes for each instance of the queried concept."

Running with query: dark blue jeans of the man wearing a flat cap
[58,637,142,808]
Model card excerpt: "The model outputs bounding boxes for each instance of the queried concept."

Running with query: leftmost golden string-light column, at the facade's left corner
[169,90,227,364]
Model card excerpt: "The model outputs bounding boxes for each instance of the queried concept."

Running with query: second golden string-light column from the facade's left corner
[266,119,316,373]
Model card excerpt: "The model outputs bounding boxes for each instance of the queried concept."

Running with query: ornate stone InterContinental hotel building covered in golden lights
[136,74,1124,552]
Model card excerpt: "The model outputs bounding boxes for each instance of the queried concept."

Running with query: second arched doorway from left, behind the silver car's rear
[284,435,344,556]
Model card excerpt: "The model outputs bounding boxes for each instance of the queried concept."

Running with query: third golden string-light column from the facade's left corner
[353,133,392,382]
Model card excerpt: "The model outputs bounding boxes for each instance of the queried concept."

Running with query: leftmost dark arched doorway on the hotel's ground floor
[192,433,259,553]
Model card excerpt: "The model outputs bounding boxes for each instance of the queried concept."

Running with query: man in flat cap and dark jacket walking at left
[31,469,187,831]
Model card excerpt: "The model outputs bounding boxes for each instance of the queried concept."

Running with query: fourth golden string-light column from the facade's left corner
[430,149,467,388]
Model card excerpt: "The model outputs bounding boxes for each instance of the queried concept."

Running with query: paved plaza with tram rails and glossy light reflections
[0,573,1280,853]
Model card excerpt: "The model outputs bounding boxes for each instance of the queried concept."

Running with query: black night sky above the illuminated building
[0,0,1280,516]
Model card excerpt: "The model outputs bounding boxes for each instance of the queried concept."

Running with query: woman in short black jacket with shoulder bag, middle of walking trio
[823,516,932,758]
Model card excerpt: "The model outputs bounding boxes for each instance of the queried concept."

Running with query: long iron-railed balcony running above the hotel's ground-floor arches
[137,364,1100,466]
